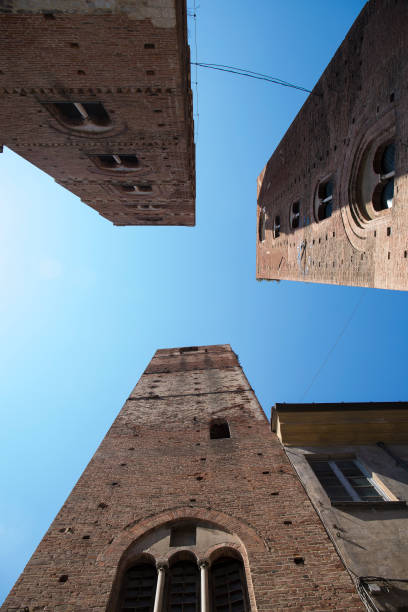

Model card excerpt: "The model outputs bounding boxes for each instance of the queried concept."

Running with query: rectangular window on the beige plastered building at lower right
[310,459,387,502]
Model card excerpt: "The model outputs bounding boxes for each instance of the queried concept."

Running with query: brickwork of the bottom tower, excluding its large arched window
[1,345,363,612]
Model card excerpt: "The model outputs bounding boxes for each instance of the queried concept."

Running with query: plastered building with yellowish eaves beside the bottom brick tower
[272,402,408,612]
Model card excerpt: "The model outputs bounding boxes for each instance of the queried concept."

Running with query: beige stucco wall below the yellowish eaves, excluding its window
[285,445,408,610]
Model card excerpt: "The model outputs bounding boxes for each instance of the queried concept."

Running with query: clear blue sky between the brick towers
[0,0,408,601]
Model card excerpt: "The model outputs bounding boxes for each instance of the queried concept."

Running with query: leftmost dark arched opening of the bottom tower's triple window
[118,563,157,612]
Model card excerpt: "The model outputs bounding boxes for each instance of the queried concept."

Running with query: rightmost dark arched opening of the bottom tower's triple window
[210,557,250,612]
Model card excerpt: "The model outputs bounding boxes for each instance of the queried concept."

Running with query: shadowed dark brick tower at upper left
[0,0,195,225]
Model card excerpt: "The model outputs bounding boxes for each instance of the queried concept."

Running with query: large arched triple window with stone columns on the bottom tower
[107,519,250,612]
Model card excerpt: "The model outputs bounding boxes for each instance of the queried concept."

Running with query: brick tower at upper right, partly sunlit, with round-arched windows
[257,0,408,290]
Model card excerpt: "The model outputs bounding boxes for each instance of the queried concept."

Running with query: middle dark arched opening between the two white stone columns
[165,561,200,612]
